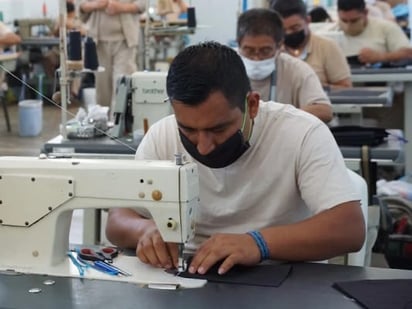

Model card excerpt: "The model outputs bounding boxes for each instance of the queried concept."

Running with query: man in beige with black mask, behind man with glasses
[271,0,352,88]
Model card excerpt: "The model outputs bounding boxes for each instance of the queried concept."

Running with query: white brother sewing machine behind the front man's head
[111,71,172,138]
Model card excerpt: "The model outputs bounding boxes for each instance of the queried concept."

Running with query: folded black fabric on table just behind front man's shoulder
[330,126,388,147]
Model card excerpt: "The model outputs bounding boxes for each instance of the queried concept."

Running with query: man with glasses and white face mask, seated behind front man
[237,9,332,122]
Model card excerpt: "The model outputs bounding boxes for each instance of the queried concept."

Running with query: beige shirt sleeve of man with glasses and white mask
[295,61,330,108]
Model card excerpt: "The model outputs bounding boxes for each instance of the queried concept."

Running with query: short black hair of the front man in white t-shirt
[166,41,251,112]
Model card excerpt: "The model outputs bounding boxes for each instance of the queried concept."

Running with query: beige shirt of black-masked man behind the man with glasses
[303,33,351,85]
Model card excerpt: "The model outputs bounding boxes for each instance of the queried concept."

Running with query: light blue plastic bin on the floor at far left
[19,100,43,137]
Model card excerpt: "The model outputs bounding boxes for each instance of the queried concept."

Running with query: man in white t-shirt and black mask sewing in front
[106,42,365,274]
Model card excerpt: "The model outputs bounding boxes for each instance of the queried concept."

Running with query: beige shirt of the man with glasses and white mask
[250,53,330,108]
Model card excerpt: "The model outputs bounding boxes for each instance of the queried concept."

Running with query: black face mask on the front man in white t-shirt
[179,130,250,168]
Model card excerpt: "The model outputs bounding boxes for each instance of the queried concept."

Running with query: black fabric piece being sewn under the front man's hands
[177,263,292,287]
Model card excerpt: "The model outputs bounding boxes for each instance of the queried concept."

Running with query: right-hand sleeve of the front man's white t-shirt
[297,124,360,214]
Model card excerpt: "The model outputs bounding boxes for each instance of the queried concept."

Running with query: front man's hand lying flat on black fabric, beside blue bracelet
[189,234,260,275]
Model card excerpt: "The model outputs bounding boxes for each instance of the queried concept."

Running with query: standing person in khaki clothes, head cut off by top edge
[80,0,145,113]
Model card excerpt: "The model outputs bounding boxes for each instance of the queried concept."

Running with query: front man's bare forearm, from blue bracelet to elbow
[261,202,365,261]
